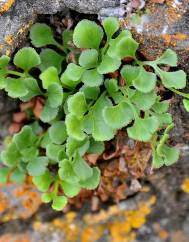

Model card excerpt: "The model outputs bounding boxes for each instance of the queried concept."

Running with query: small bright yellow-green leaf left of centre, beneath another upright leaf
[65,114,86,141]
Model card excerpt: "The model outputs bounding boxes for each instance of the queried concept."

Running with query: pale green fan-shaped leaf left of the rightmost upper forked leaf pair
[133,67,156,93]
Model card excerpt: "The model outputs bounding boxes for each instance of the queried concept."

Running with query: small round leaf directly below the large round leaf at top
[79,49,98,69]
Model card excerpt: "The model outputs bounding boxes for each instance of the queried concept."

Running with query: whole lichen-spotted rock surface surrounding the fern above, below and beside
[0,0,189,242]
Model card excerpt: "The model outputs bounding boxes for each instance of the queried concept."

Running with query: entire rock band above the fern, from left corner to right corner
[0,0,189,73]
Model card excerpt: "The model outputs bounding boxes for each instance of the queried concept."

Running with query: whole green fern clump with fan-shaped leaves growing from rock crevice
[0,17,189,210]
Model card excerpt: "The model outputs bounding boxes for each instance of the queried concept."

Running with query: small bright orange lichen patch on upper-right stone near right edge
[161,33,188,46]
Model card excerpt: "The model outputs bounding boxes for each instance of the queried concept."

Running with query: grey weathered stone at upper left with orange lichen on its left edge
[0,0,119,55]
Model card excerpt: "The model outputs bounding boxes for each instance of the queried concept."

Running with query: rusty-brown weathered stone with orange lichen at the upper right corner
[123,0,189,73]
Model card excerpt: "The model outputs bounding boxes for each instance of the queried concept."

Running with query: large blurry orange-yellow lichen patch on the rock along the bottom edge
[30,196,156,242]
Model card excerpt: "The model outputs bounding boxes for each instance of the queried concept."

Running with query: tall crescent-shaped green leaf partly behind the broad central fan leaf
[89,95,115,141]
